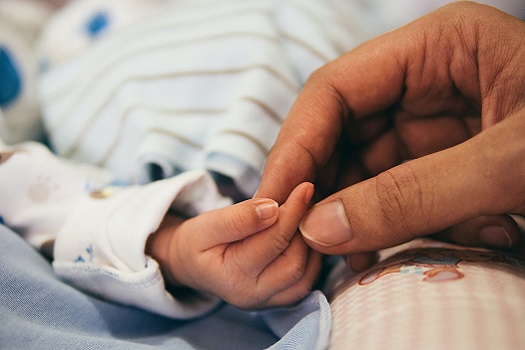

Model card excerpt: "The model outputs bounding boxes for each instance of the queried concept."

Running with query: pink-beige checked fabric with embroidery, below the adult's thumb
[330,241,525,350]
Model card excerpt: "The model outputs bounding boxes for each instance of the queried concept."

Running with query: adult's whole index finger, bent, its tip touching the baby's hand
[257,2,479,203]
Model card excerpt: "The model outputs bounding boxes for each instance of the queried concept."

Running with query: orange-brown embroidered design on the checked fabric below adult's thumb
[359,248,519,286]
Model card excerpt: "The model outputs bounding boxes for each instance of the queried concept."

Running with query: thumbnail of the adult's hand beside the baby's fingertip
[299,200,352,247]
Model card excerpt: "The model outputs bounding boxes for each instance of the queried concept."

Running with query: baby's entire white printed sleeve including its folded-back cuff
[0,141,231,319]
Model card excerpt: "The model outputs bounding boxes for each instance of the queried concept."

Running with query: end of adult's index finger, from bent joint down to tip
[255,78,346,203]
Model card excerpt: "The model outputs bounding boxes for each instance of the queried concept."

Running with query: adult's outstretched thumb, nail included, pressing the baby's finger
[300,117,525,254]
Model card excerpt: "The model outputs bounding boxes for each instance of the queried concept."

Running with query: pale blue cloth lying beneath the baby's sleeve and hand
[0,225,331,350]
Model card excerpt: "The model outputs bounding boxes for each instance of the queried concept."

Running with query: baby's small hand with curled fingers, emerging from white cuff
[146,183,321,309]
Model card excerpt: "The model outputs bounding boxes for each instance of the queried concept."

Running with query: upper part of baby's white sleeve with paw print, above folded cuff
[0,141,112,249]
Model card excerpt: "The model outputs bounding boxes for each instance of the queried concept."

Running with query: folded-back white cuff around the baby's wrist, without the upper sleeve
[53,171,230,319]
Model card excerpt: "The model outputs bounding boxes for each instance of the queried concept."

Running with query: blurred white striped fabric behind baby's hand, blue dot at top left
[36,0,367,197]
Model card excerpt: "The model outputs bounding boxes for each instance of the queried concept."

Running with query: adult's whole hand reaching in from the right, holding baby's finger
[257,2,525,269]
